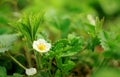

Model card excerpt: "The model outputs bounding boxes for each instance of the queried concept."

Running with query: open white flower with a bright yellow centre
[33,39,51,52]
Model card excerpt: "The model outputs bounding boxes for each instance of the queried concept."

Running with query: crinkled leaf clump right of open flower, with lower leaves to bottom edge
[46,34,84,77]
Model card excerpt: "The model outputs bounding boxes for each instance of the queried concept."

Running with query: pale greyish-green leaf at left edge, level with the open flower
[0,34,17,53]
